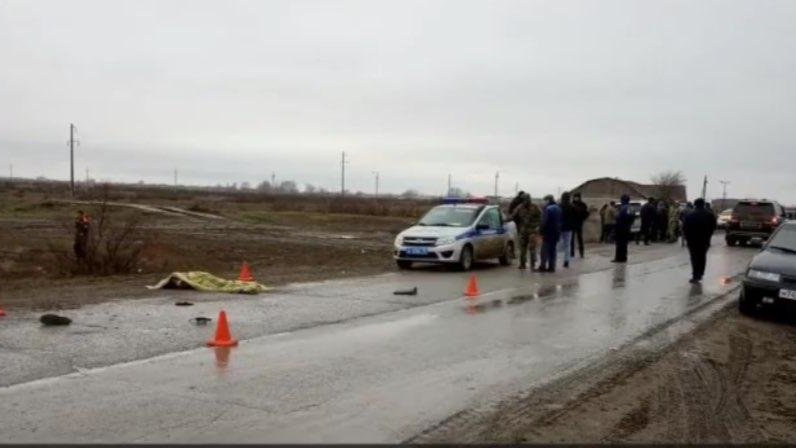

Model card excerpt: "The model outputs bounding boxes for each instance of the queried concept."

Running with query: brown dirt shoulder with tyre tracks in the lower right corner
[422,307,796,444]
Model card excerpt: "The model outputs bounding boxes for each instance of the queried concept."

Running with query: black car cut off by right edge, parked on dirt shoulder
[738,221,796,314]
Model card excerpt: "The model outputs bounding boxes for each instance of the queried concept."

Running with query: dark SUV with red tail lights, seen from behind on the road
[724,200,787,246]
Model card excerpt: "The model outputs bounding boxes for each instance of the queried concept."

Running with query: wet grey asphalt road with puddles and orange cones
[0,239,755,443]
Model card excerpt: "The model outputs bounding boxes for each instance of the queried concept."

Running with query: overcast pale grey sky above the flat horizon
[0,0,796,200]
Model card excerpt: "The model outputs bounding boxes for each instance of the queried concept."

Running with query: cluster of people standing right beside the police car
[508,191,589,272]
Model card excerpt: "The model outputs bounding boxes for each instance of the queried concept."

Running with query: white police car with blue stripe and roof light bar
[393,199,517,271]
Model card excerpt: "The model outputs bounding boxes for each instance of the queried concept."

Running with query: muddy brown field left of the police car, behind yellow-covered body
[0,187,413,309]
